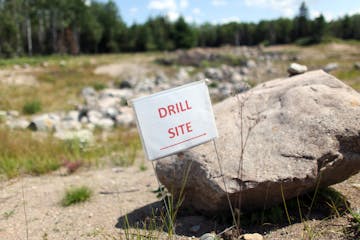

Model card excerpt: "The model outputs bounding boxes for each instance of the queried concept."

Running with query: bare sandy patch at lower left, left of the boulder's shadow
[0,167,158,240]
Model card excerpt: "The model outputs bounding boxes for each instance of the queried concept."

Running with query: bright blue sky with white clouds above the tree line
[108,0,360,25]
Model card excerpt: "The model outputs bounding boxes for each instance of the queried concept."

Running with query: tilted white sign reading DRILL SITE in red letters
[132,81,218,160]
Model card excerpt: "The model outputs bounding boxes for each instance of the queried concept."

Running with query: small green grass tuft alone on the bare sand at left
[61,186,92,207]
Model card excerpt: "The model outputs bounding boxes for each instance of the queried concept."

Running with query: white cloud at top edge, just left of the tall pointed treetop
[245,0,302,17]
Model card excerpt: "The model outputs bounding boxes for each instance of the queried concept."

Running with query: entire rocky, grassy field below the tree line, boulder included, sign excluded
[0,43,360,239]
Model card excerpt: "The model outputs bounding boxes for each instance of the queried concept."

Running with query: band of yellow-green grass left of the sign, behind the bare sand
[0,128,140,178]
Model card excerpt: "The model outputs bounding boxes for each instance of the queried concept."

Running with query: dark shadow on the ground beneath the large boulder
[115,188,349,239]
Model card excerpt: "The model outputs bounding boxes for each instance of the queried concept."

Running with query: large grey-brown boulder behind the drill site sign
[156,70,360,213]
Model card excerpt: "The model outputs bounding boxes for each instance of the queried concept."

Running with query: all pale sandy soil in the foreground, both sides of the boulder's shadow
[0,164,360,240]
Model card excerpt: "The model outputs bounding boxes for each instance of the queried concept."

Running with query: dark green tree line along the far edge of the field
[0,0,360,57]
